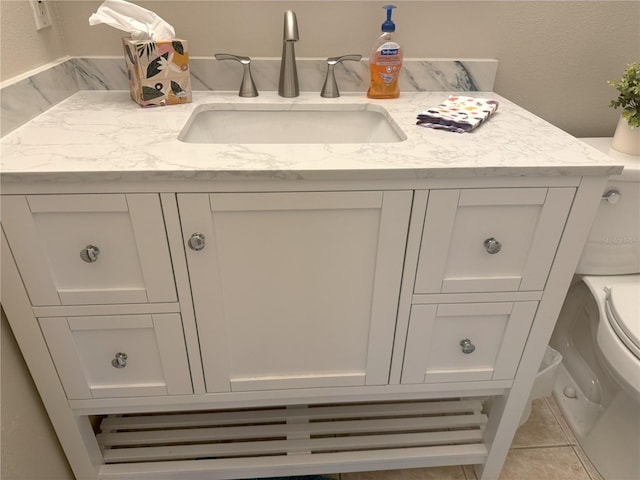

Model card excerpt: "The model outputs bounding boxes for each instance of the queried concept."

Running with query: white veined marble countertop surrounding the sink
[0,91,622,186]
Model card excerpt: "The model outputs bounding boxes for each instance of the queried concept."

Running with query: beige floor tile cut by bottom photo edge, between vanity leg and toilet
[499,446,590,480]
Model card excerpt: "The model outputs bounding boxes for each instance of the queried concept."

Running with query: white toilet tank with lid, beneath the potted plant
[576,138,640,275]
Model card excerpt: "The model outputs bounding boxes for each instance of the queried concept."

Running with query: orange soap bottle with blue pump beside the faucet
[367,5,402,98]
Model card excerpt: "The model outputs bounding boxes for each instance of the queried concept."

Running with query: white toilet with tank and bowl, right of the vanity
[551,138,640,480]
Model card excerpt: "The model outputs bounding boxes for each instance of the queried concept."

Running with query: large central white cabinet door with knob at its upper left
[178,191,412,391]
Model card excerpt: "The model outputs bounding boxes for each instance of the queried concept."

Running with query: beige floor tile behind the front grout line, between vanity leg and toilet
[511,398,571,448]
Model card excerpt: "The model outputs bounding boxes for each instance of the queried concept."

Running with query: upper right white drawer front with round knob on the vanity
[415,188,575,294]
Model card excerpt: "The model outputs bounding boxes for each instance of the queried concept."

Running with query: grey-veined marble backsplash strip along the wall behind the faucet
[0,57,498,136]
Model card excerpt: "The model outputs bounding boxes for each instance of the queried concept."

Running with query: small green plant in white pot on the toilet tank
[608,63,640,155]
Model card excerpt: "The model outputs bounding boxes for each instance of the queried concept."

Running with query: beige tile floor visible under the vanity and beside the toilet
[333,396,603,480]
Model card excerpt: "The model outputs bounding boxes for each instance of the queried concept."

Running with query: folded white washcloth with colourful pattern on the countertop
[418,95,498,133]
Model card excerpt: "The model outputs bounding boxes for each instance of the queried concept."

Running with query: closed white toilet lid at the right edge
[606,285,640,359]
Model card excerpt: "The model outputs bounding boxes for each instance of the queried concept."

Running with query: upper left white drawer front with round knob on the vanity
[2,194,177,306]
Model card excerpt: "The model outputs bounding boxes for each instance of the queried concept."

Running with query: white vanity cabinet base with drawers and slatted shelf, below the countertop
[2,178,604,480]
